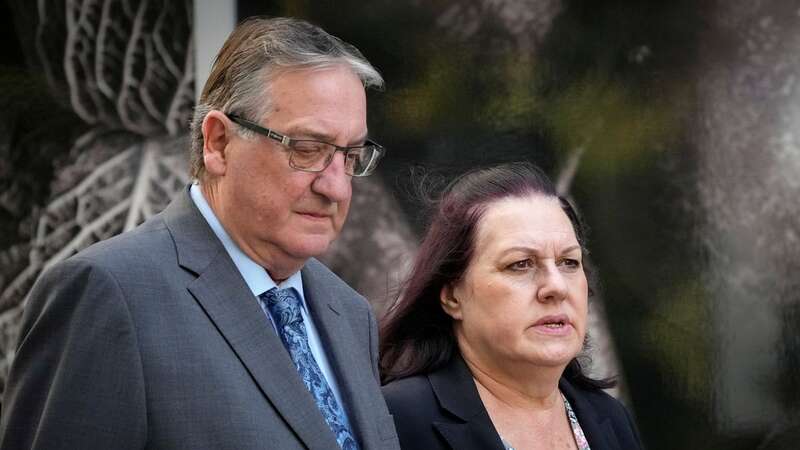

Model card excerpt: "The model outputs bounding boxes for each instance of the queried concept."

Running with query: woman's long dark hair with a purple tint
[380,162,615,389]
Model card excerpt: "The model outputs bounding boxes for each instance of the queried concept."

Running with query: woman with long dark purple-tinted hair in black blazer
[380,163,641,450]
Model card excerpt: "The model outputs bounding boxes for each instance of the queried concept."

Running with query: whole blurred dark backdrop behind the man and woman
[0,0,800,450]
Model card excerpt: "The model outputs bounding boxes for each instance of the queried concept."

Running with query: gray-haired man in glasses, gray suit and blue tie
[0,18,398,450]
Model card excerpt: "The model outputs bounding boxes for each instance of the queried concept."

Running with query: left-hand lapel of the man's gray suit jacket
[165,192,337,449]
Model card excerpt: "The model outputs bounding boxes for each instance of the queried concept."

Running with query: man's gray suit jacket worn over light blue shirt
[0,188,399,450]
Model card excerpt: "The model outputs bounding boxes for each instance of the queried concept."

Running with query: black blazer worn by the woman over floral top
[383,355,642,450]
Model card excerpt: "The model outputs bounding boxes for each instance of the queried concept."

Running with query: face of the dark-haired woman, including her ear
[441,194,588,368]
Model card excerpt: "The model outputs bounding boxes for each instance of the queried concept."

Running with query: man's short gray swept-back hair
[190,17,383,180]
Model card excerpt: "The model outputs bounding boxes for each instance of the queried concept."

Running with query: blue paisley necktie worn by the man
[258,288,358,450]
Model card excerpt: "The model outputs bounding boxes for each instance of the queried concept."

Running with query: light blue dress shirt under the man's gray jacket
[189,183,347,418]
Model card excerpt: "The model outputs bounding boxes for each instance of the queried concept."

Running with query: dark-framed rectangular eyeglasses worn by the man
[225,114,386,177]
